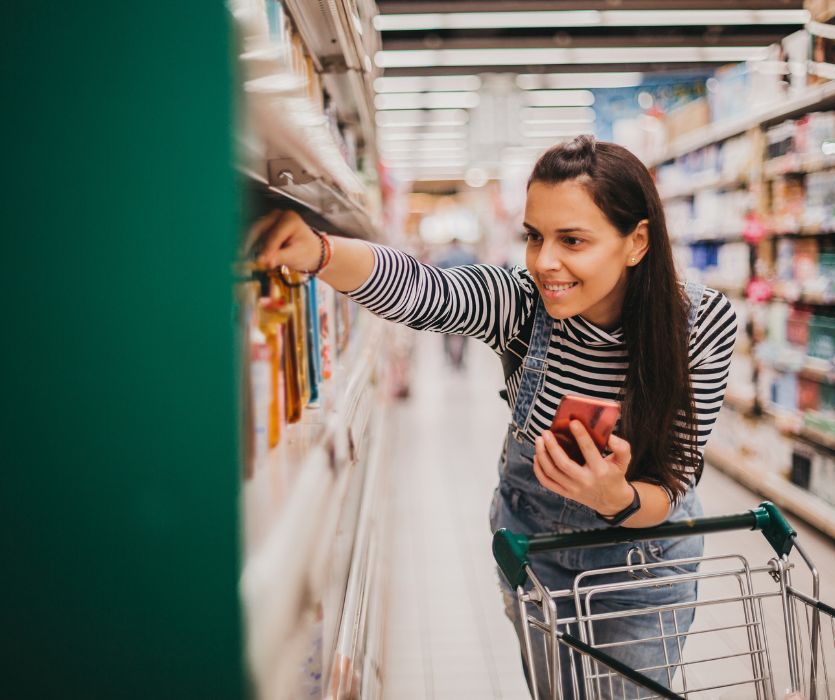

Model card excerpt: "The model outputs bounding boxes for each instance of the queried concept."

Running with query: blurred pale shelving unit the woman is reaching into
[233,0,388,698]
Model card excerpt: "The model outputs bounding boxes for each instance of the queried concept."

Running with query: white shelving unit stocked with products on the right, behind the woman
[651,83,835,537]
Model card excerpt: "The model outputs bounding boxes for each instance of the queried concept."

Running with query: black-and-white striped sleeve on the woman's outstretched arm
[347,245,533,353]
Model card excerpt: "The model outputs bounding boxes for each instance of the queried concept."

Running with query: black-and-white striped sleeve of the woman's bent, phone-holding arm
[676,289,737,500]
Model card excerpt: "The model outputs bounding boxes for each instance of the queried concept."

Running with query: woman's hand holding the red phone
[533,420,634,515]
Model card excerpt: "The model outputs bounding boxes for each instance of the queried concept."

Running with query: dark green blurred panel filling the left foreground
[0,1,245,699]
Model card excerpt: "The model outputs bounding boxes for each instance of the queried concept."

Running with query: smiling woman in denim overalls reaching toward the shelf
[258,136,736,697]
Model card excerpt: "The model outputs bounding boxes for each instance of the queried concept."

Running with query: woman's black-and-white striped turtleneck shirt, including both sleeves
[348,246,736,492]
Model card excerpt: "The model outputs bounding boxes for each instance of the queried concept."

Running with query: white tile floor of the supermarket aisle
[383,333,835,700]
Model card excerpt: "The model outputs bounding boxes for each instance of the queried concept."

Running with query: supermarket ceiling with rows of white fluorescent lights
[376,0,805,182]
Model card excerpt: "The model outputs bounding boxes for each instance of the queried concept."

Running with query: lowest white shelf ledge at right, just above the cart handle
[705,444,835,538]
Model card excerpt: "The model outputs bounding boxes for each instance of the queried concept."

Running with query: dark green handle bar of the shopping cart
[493,501,797,588]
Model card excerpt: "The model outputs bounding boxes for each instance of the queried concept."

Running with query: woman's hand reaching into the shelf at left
[246,211,322,272]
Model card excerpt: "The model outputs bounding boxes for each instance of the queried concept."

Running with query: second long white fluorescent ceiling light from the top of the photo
[374,46,768,68]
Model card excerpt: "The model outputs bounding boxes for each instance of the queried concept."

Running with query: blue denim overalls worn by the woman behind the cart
[490,283,704,699]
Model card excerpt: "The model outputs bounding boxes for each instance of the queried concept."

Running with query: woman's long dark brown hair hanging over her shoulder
[528,136,699,497]
